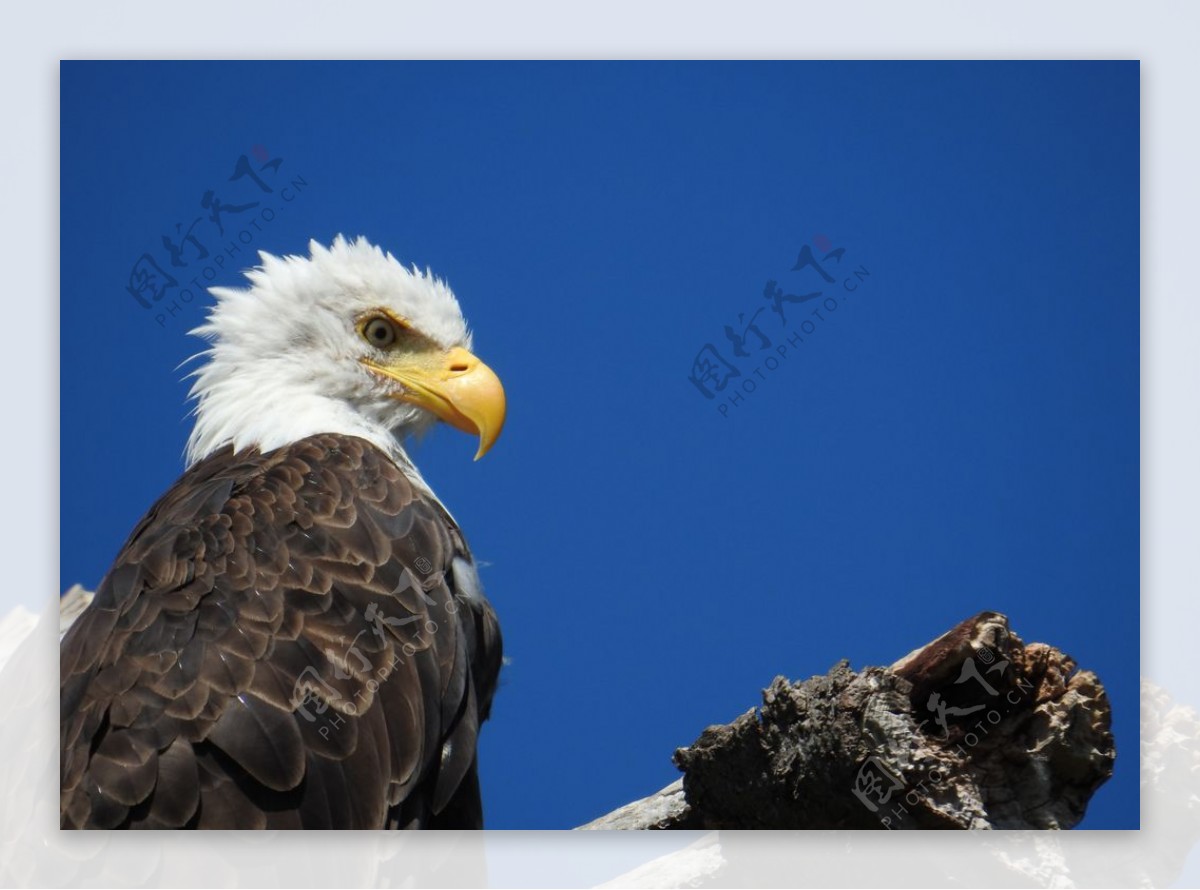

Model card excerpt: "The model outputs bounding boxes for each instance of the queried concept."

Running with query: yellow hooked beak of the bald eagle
[360,347,504,461]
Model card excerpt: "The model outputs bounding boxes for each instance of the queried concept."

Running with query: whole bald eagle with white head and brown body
[60,236,505,829]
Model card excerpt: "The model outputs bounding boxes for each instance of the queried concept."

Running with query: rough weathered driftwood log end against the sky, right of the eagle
[581,612,1116,829]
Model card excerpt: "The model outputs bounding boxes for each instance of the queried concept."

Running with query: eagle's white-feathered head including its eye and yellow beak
[187,235,505,464]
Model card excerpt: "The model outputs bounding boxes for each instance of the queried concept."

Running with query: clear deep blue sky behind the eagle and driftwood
[61,62,1139,828]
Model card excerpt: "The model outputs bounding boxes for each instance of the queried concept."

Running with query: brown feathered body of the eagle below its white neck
[60,435,500,828]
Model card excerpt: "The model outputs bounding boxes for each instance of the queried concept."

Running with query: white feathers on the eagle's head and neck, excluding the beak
[187,235,470,481]
